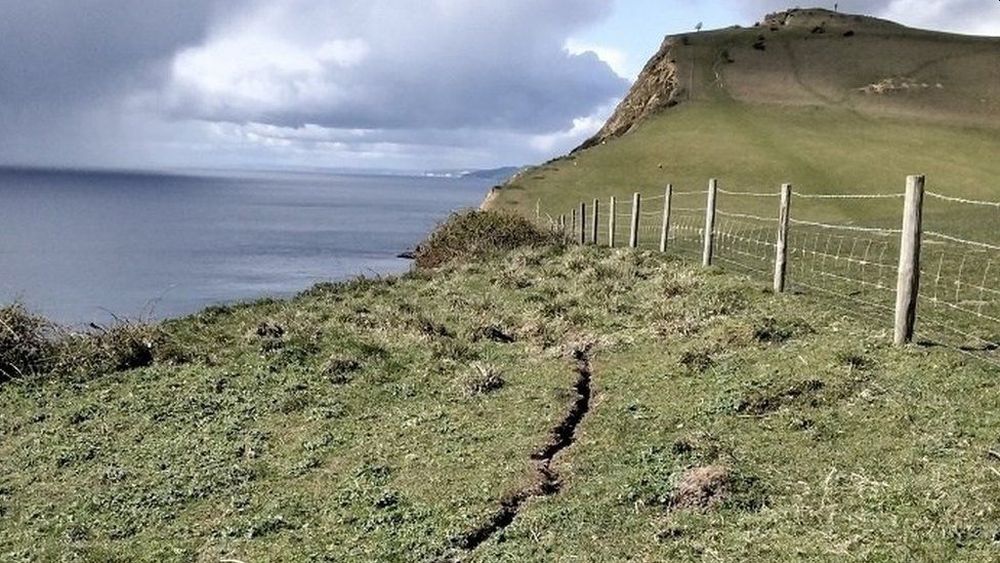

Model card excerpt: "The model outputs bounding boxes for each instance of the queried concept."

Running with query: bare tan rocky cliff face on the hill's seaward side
[573,37,680,152]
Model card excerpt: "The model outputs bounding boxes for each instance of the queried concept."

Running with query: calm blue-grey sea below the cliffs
[0,169,490,325]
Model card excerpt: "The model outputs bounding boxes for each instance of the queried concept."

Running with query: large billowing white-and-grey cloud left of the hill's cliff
[161,0,627,133]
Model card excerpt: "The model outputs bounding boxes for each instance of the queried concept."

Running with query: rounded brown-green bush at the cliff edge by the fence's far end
[414,211,561,268]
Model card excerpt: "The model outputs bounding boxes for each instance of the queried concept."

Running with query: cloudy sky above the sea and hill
[0,0,1000,171]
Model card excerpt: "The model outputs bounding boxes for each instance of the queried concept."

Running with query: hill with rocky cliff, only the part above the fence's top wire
[489,9,1000,227]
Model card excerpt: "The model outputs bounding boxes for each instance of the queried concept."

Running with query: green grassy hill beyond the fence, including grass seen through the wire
[487,10,1000,360]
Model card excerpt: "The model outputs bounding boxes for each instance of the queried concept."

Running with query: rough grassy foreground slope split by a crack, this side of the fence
[0,248,1000,561]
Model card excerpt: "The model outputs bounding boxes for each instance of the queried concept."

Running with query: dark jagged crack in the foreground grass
[455,347,592,551]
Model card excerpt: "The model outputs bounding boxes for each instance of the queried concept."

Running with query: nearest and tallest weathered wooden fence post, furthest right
[895,176,925,346]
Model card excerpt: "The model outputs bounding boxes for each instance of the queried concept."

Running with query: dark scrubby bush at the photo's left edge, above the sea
[0,303,54,383]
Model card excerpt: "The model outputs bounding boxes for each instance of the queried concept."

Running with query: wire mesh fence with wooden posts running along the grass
[549,177,1000,366]
